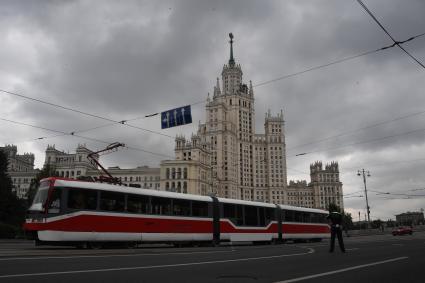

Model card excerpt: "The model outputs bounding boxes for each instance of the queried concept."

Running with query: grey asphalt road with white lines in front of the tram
[0,232,425,283]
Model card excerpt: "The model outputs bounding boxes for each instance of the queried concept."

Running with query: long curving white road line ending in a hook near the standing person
[0,248,314,278]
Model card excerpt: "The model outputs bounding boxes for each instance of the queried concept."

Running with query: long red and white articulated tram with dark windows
[24,177,330,245]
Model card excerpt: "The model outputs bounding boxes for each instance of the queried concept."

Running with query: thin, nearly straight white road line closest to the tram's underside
[0,250,234,261]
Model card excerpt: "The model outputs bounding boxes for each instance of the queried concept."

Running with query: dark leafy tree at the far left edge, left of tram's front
[0,150,25,229]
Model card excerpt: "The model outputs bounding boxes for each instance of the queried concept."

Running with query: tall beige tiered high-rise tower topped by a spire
[161,34,287,203]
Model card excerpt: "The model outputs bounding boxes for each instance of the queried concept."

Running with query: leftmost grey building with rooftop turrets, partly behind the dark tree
[0,145,39,199]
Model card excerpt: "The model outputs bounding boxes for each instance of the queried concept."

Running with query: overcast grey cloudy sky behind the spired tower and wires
[0,0,425,220]
